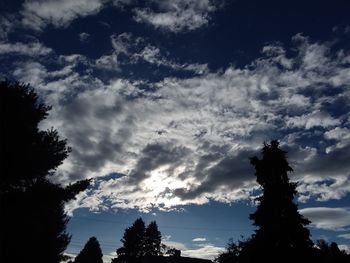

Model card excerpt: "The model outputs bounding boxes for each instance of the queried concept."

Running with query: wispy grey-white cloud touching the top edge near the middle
[134,0,216,33]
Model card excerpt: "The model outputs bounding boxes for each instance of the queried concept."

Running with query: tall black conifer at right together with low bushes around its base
[215,141,350,263]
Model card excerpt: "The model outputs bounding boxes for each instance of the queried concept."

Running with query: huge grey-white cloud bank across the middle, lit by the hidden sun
[7,33,350,214]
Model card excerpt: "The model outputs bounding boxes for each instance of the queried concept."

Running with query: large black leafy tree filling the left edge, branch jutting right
[0,81,89,263]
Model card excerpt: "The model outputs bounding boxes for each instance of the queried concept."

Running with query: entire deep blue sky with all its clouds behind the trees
[0,0,350,262]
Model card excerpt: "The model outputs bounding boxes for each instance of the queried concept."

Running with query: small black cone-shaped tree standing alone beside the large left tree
[74,237,103,263]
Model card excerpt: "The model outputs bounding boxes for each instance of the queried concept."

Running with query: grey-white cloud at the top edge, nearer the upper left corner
[21,0,106,30]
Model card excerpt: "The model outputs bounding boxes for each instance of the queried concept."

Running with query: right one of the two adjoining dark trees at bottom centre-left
[144,221,162,256]
